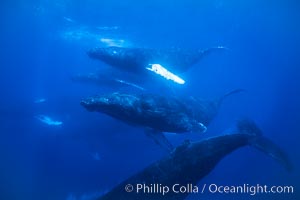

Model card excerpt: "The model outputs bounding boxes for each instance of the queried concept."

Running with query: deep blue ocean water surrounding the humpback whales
[0,0,300,200]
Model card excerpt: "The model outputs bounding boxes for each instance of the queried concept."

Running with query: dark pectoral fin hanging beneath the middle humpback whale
[145,128,174,152]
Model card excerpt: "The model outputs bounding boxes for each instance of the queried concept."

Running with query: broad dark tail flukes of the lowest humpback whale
[237,119,293,171]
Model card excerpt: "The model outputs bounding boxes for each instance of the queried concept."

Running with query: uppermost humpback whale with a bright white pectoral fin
[87,46,226,84]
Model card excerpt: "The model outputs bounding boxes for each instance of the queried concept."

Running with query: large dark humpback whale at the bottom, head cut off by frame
[98,120,292,200]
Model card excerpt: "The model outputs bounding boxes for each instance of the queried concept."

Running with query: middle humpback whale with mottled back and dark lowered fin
[81,89,243,150]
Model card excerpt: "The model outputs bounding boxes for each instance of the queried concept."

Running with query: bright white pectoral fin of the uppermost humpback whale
[146,64,185,85]
